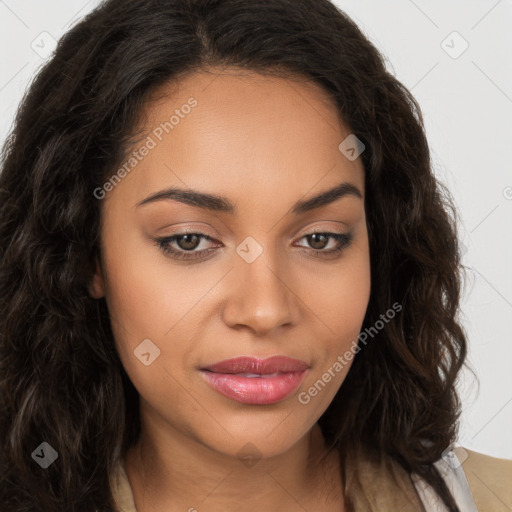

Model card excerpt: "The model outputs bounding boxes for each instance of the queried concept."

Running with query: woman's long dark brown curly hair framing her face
[0,0,467,512]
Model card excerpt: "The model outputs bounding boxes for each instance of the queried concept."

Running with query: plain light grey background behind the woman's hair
[0,0,512,459]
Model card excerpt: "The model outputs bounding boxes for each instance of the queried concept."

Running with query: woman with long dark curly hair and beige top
[0,0,512,512]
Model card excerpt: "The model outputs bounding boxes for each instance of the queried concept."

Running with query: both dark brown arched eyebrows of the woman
[136,182,363,215]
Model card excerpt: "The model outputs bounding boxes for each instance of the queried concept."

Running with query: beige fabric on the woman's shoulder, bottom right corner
[454,446,512,512]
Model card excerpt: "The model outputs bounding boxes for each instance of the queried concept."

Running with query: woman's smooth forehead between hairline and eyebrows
[109,70,364,210]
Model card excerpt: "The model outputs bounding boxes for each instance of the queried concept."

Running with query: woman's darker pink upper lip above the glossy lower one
[202,356,309,375]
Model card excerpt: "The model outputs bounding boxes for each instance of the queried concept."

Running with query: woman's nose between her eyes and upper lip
[223,244,302,336]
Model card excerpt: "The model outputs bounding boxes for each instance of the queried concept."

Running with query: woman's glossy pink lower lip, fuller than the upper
[201,370,307,405]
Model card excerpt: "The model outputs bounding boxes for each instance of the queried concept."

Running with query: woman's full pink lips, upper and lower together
[201,356,309,405]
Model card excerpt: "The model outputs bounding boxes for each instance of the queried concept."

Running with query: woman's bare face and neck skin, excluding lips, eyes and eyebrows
[91,69,370,512]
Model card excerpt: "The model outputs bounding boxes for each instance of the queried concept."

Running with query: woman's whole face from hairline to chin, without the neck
[91,71,370,457]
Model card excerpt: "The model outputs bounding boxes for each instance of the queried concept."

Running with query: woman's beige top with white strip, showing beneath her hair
[111,448,512,512]
